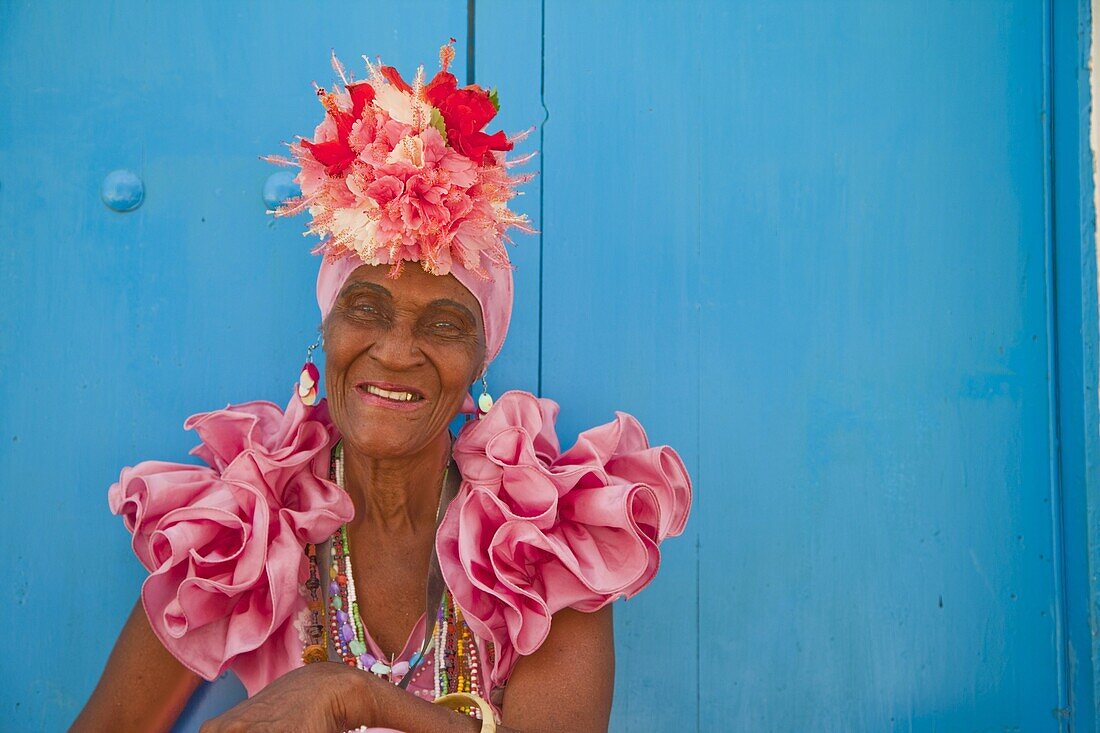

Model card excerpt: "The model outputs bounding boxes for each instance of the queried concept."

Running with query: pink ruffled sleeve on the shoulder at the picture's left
[108,387,353,696]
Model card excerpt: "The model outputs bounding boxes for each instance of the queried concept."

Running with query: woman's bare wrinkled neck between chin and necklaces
[343,430,451,534]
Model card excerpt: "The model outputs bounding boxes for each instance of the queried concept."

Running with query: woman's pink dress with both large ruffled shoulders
[108,392,692,726]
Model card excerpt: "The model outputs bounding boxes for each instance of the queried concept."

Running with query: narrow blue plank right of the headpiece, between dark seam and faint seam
[542,2,704,731]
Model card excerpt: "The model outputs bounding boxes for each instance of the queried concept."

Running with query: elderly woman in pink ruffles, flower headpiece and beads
[75,45,691,732]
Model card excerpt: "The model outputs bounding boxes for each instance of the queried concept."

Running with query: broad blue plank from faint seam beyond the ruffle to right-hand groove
[700,2,1059,731]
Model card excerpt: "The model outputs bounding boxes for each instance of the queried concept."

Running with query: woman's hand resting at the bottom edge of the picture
[199,661,374,733]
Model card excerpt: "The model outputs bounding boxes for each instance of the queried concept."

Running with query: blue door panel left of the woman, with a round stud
[0,0,466,731]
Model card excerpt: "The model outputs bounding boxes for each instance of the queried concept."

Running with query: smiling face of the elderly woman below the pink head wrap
[323,265,485,458]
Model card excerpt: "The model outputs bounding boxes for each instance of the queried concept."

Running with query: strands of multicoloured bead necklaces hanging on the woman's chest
[303,441,493,718]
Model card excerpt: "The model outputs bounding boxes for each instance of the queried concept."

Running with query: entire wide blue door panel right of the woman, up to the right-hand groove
[542,2,1060,730]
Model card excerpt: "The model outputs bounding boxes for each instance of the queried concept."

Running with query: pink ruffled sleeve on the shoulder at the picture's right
[437,392,692,685]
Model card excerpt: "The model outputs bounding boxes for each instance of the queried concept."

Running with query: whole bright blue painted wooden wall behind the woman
[0,0,1100,731]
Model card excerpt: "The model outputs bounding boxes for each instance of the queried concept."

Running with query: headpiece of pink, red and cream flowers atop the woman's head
[264,39,534,278]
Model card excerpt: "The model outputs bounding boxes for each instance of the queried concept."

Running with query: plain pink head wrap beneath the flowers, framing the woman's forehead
[317,254,513,413]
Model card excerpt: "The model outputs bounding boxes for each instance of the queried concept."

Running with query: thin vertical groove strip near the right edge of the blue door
[1042,0,1070,717]
